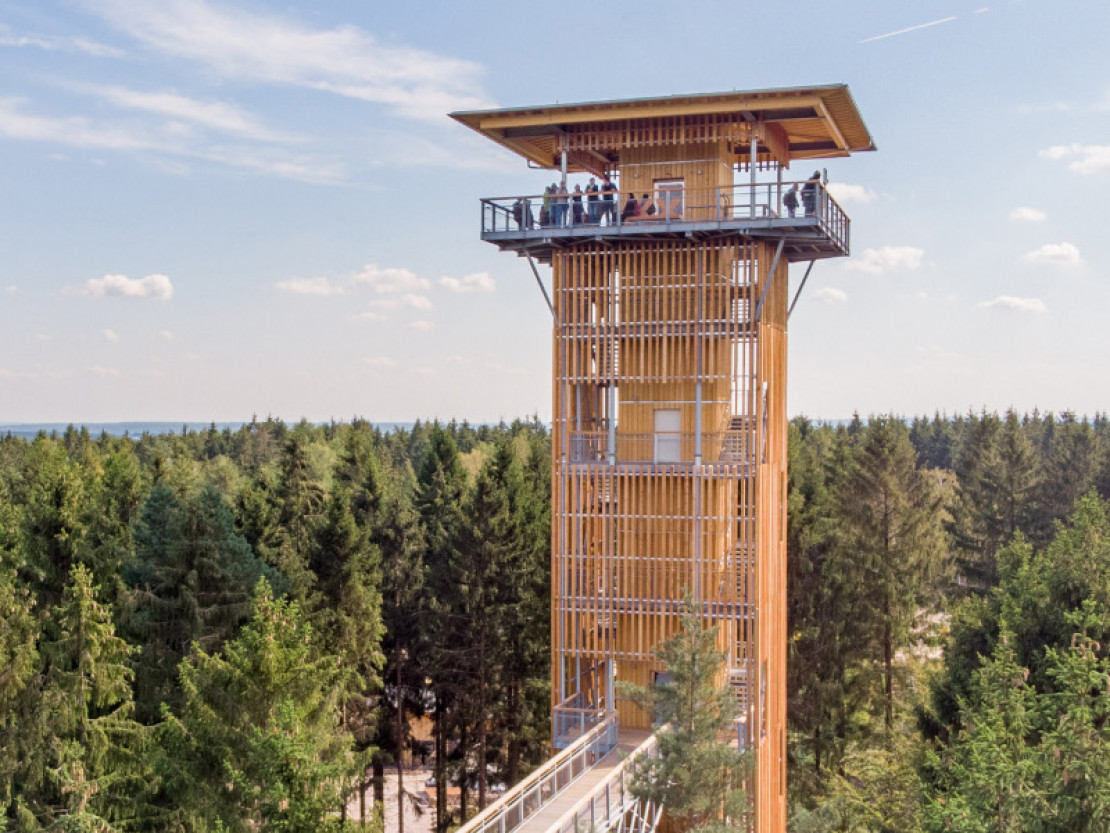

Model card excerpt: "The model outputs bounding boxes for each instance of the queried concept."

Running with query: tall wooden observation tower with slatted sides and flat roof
[453,84,875,833]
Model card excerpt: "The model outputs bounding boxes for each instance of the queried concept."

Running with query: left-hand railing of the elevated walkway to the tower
[455,712,619,833]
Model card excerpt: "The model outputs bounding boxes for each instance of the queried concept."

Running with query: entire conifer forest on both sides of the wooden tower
[0,412,1110,833]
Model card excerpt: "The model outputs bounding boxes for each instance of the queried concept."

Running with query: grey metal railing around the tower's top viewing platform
[482,182,849,256]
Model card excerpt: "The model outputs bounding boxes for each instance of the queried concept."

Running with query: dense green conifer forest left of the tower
[0,419,551,831]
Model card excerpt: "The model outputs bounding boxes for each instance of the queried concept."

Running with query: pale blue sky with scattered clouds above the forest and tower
[0,0,1110,423]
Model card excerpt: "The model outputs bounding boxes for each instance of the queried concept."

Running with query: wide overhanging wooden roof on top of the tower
[451,84,875,172]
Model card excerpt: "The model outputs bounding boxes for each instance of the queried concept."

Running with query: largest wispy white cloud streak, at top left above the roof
[89,0,491,119]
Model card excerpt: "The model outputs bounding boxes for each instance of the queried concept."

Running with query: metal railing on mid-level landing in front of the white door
[571,431,751,465]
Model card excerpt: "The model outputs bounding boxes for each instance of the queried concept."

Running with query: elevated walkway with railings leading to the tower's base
[456,714,660,833]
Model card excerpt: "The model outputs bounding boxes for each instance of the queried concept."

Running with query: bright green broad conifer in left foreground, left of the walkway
[159,579,365,833]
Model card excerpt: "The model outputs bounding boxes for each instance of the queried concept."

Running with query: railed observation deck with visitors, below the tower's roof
[482,182,851,263]
